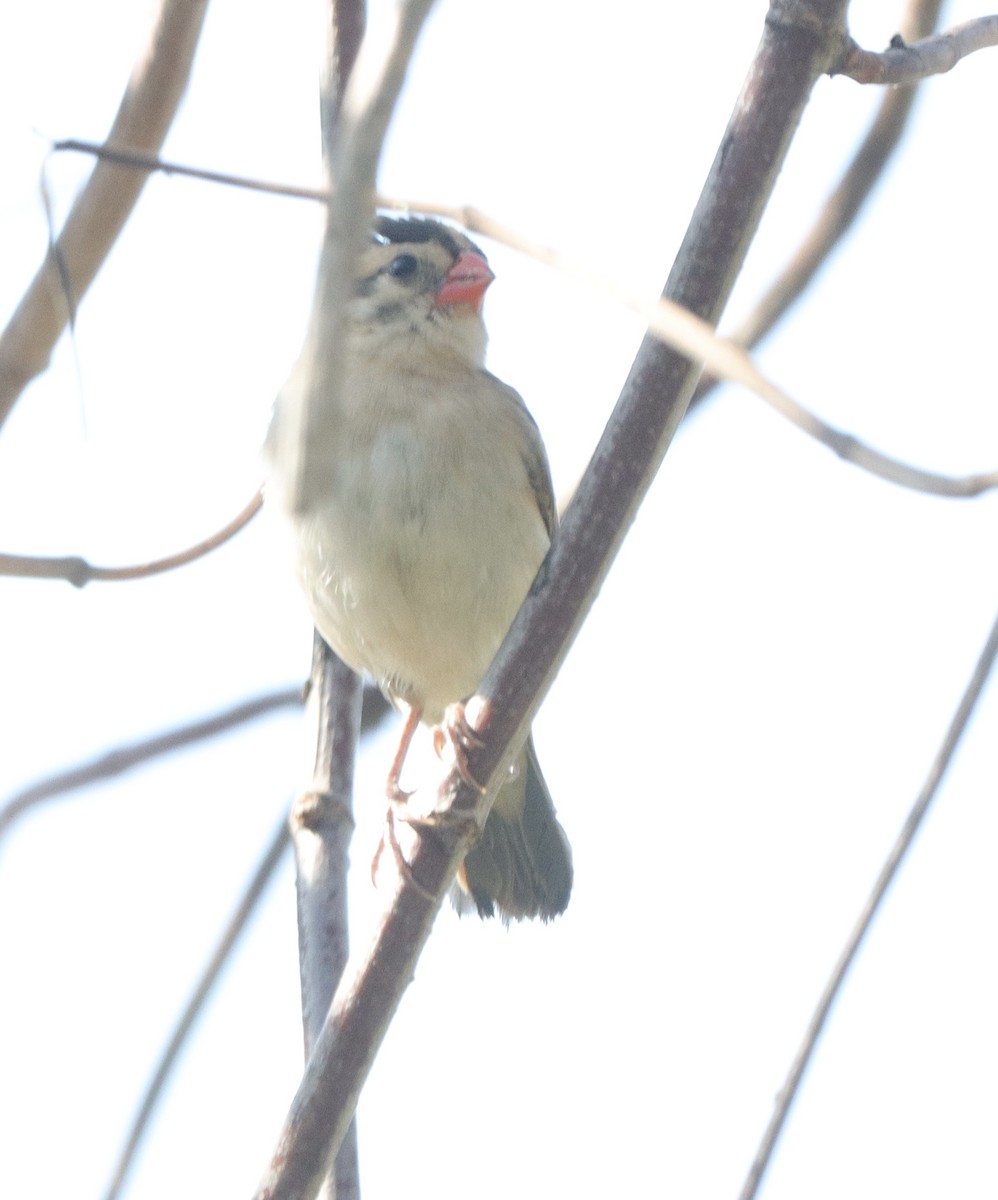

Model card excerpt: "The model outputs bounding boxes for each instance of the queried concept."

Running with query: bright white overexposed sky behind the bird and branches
[0,0,998,1200]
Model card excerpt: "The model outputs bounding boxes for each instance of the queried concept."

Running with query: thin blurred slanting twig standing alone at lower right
[740,604,998,1200]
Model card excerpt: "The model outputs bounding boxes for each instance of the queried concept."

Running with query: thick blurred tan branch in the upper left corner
[0,0,208,425]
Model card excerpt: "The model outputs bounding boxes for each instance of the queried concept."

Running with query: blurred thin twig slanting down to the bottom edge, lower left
[104,817,289,1200]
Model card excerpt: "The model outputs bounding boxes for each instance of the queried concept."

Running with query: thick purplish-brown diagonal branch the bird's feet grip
[258,0,846,1200]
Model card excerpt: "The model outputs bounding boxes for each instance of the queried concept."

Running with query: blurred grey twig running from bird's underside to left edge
[0,686,303,840]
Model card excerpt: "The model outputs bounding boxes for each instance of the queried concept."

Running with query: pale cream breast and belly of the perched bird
[297,352,548,721]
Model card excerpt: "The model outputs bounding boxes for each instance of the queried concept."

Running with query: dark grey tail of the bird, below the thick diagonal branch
[458,738,572,920]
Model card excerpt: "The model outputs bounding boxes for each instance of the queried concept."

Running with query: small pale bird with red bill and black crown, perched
[268,217,572,919]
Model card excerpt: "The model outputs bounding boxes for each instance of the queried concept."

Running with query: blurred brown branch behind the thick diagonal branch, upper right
[690,0,943,408]
